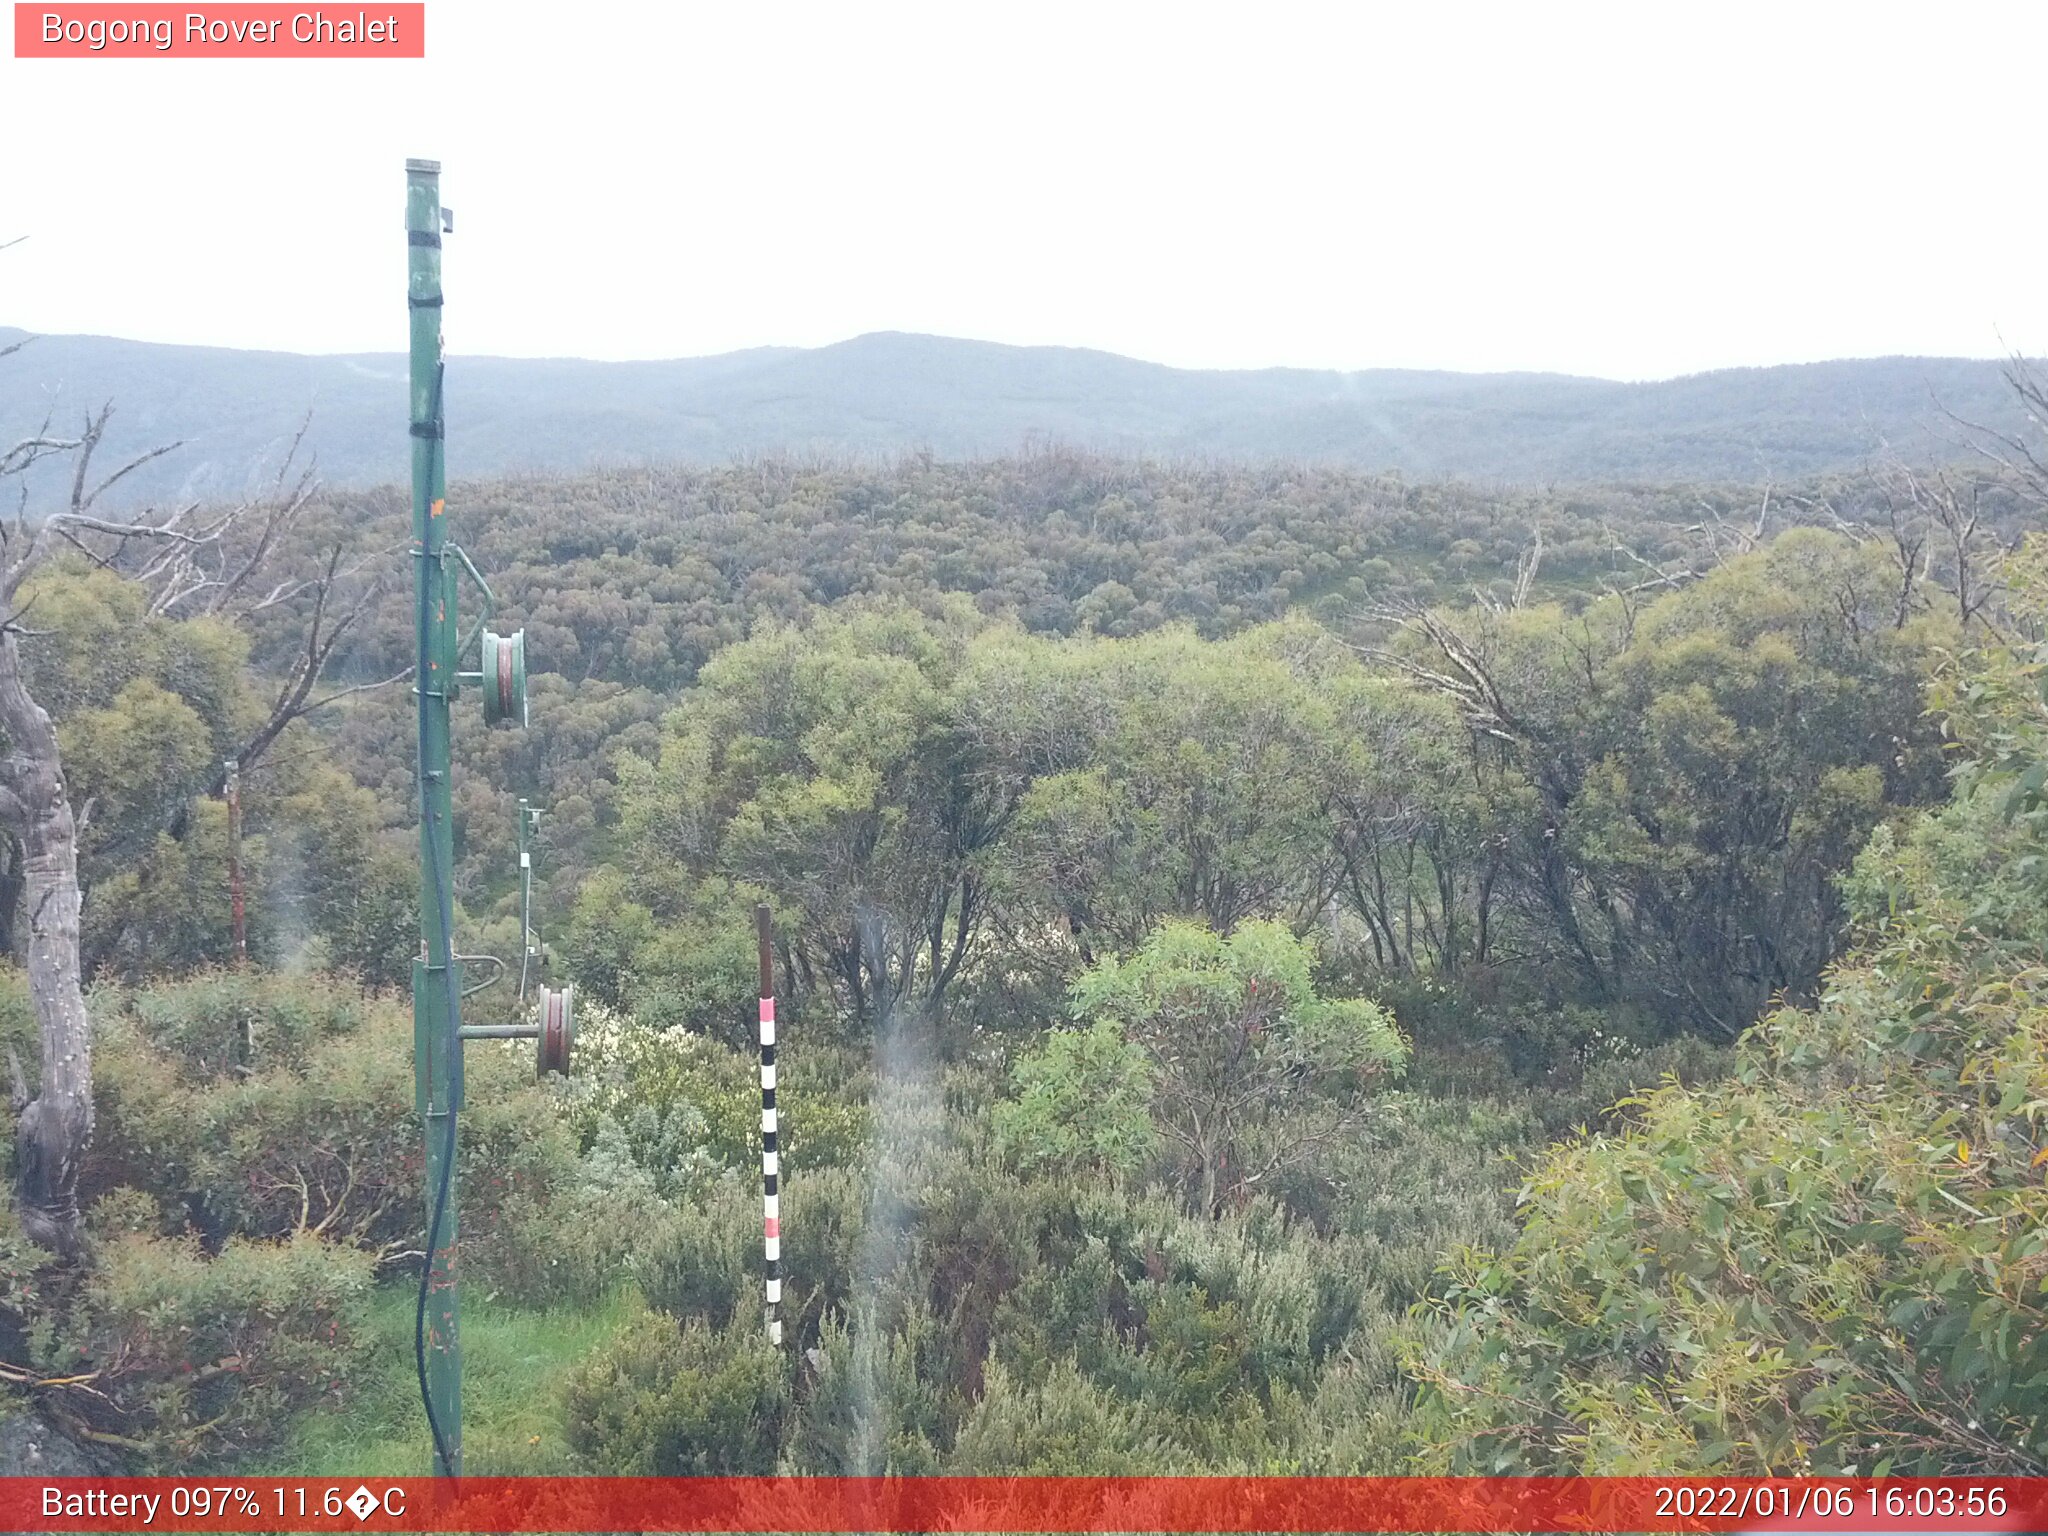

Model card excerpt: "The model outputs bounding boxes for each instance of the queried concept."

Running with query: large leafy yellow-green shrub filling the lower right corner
[1411,655,2048,1477]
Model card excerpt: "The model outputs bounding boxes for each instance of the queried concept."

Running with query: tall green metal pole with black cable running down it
[406,160,463,1477]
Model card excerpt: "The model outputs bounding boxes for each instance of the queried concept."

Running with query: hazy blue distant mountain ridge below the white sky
[0,328,2023,496]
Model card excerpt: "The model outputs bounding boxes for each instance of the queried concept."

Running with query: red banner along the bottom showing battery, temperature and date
[0,1477,2048,1532]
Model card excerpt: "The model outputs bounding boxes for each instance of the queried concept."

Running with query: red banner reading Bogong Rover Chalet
[14,0,426,59]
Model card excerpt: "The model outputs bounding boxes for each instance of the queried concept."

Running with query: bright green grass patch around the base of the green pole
[276,1284,641,1477]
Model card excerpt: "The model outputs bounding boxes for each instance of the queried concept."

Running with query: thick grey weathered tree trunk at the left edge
[0,631,92,1257]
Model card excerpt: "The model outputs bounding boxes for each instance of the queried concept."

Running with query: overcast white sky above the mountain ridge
[0,0,2048,379]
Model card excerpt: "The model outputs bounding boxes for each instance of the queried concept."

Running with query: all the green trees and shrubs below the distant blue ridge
[0,415,2048,1475]
